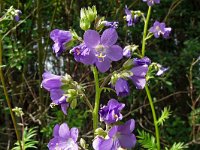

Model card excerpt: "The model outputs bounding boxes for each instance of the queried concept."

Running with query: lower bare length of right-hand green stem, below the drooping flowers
[145,85,160,150]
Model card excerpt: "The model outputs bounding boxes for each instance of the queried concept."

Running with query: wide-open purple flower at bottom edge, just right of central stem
[93,119,136,150]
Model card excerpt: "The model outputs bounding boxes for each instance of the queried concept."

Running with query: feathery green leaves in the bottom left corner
[12,127,38,150]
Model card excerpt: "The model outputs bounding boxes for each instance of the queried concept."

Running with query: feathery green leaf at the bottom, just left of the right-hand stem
[137,130,157,150]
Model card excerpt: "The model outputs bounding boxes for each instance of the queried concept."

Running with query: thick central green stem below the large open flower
[92,66,101,131]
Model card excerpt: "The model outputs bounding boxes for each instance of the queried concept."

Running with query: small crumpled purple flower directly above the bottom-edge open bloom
[99,99,125,124]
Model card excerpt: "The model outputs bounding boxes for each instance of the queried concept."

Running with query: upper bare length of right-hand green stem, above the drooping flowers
[142,6,151,57]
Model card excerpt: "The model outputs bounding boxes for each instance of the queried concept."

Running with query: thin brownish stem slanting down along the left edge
[0,36,23,150]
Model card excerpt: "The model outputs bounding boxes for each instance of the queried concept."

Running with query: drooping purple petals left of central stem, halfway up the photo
[41,72,69,114]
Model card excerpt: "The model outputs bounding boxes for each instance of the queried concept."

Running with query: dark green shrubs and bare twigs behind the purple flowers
[0,0,200,150]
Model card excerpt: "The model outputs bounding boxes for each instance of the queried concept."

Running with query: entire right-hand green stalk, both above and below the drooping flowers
[142,6,160,150]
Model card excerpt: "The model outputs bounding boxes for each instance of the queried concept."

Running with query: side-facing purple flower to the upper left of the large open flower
[50,29,72,57]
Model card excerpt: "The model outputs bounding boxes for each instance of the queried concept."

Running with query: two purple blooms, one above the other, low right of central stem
[93,99,136,150]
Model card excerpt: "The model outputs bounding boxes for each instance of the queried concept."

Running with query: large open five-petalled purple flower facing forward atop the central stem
[84,28,123,72]
